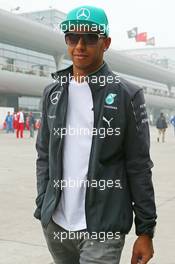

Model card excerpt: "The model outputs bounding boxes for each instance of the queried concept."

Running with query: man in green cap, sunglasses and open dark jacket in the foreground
[35,6,156,264]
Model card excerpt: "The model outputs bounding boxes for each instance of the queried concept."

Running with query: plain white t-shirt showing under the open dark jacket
[53,80,94,231]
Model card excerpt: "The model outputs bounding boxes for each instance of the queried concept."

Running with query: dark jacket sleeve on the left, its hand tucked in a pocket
[34,87,49,219]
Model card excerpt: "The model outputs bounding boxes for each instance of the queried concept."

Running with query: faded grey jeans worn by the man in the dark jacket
[43,220,125,264]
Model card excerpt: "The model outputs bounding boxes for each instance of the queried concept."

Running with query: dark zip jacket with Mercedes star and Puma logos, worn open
[34,64,156,237]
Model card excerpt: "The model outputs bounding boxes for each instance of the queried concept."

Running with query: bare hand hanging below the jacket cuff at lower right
[131,235,154,264]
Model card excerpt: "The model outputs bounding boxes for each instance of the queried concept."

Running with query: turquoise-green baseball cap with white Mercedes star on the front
[60,6,109,36]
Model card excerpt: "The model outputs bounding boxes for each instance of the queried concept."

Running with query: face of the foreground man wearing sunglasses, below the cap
[67,27,111,72]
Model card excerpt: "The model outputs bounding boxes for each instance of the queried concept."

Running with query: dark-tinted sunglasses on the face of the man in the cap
[65,32,106,47]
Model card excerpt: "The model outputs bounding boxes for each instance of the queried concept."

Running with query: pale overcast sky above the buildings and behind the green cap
[0,0,175,49]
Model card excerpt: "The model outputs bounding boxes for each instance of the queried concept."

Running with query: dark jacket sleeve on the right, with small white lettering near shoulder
[125,90,157,237]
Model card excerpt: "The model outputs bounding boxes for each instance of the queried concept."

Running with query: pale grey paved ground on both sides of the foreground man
[0,128,175,264]
